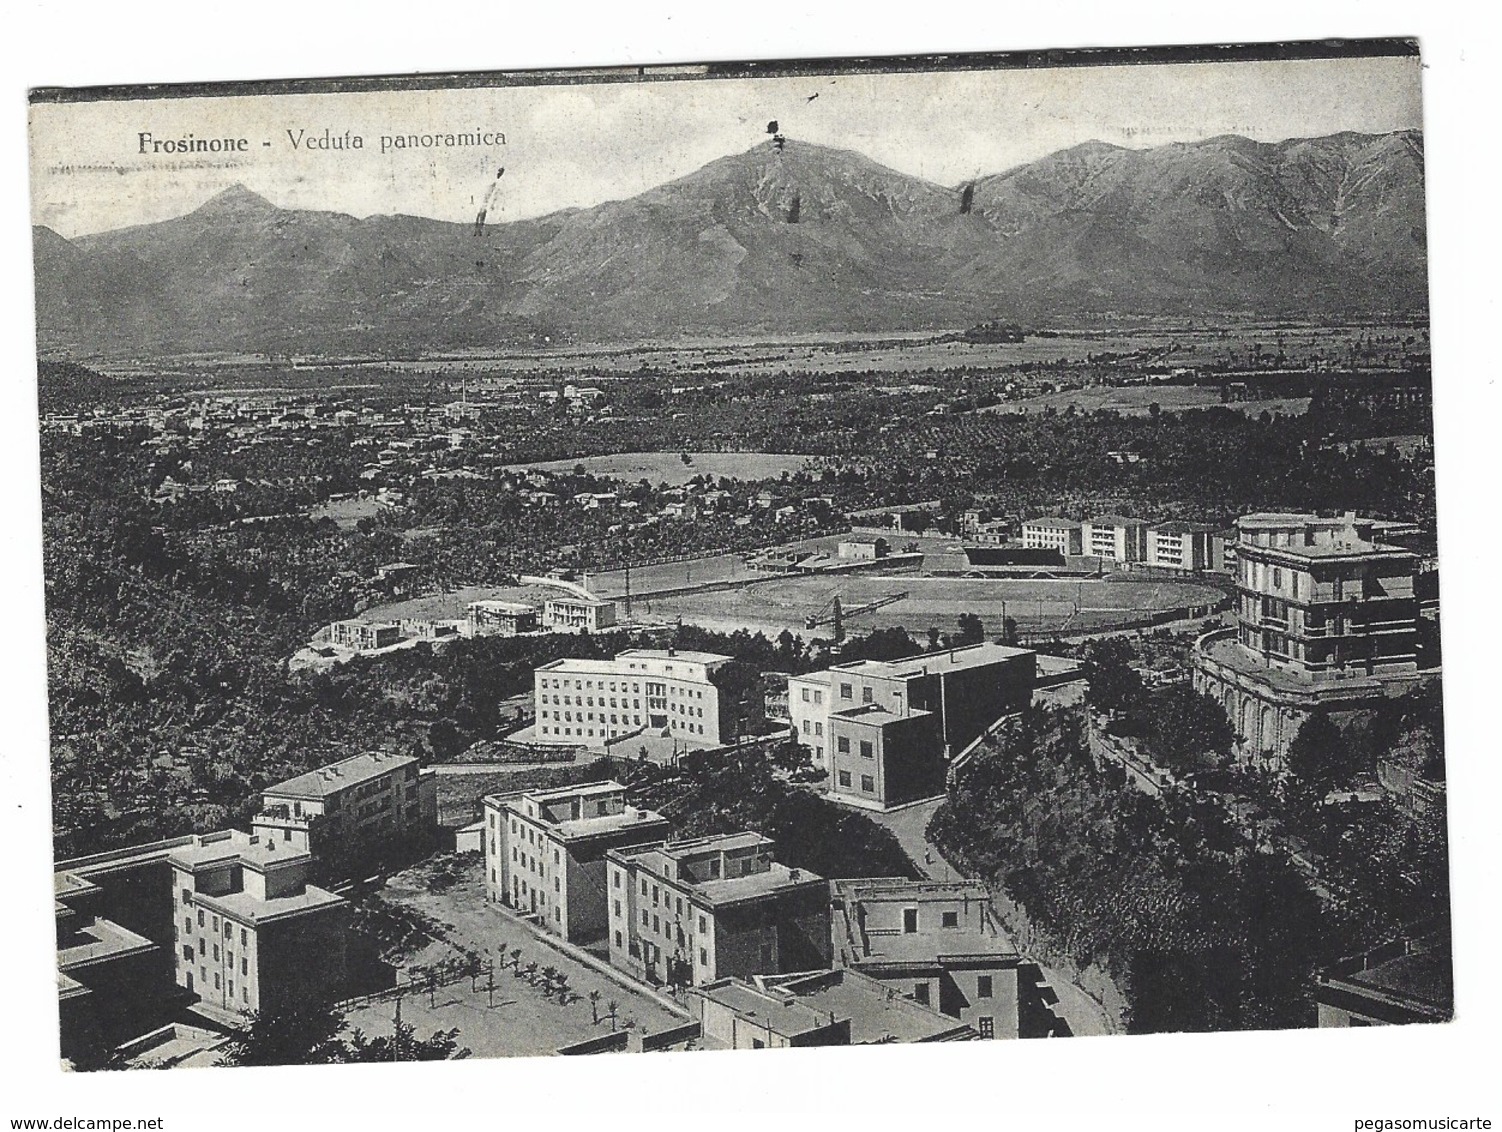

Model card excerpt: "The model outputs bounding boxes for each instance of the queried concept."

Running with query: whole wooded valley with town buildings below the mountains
[42,319,1451,1067]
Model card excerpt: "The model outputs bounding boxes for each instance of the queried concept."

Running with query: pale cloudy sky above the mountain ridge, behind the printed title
[32,57,1422,236]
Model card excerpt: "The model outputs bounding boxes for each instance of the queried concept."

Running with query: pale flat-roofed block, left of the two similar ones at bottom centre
[481,782,673,941]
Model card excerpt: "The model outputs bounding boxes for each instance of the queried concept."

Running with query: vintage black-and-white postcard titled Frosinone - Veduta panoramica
[30,41,1454,1070]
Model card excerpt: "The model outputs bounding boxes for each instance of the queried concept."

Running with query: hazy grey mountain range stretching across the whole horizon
[35,131,1427,354]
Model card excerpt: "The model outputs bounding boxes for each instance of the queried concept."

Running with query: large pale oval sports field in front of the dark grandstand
[634,575,1221,637]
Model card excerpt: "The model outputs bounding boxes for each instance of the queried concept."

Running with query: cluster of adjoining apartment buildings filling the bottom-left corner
[53,754,437,1058]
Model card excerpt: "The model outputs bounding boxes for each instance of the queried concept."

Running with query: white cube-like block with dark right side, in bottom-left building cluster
[168,830,348,1012]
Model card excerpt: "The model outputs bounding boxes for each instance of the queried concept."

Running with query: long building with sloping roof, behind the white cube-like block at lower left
[251,752,439,871]
